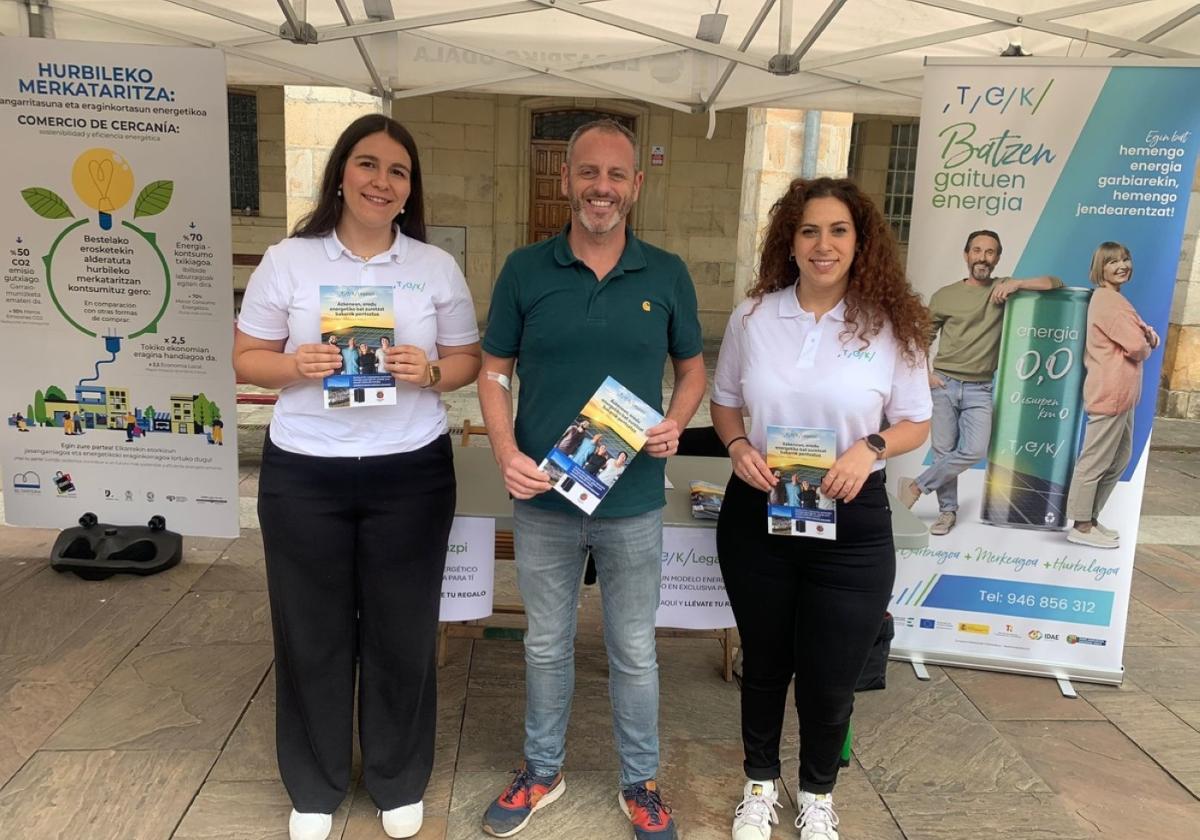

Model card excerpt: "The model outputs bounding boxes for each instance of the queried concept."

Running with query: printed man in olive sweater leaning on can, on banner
[896,230,1062,536]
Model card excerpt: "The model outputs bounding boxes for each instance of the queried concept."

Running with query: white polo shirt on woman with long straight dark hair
[238,228,479,457]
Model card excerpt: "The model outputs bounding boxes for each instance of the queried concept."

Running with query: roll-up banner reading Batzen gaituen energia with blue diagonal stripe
[888,58,1200,682]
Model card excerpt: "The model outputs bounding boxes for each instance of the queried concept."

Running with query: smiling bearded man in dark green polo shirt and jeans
[479,120,704,840]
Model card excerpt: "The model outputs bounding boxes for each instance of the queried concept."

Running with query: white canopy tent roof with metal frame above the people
[0,0,1200,114]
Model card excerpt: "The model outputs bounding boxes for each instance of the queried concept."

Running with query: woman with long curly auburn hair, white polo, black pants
[712,178,931,840]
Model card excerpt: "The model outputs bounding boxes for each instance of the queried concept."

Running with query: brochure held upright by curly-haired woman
[767,426,838,540]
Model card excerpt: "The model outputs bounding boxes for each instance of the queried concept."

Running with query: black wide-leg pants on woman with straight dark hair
[258,436,455,814]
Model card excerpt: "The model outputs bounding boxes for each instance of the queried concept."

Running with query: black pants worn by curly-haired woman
[716,473,895,793]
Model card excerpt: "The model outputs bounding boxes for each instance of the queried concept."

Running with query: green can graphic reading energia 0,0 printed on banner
[983,288,1092,530]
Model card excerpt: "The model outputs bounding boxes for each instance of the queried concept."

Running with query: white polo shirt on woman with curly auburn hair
[713,287,932,469]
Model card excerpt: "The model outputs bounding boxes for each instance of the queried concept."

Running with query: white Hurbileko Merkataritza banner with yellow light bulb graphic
[0,38,238,536]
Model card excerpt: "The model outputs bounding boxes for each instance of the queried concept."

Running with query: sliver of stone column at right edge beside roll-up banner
[1158,159,1200,420]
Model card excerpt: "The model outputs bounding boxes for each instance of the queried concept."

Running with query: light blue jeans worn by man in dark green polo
[512,502,662,785]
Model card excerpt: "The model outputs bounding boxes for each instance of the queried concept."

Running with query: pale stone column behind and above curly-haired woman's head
[733,108,854,300]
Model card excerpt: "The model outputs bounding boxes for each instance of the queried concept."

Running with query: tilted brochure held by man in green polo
[539,377,662,514]
